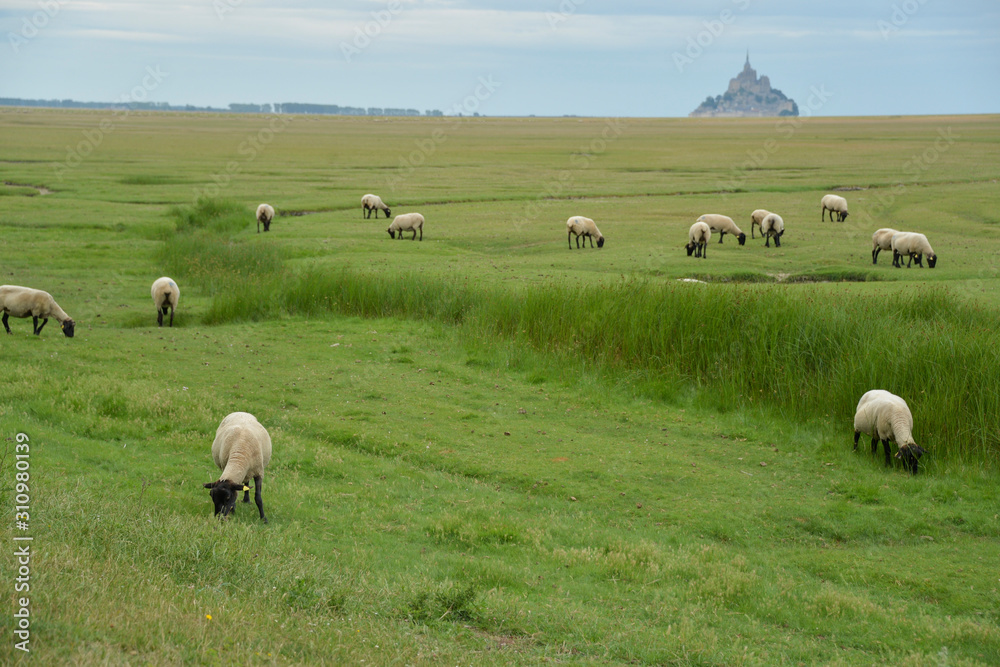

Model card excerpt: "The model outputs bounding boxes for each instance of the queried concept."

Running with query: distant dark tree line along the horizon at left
[0,97,444,116]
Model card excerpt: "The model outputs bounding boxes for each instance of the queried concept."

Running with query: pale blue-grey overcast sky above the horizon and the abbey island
[0,0,1000,116]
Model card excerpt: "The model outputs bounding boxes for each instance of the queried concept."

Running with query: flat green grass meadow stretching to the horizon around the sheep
[0,109,1000,665]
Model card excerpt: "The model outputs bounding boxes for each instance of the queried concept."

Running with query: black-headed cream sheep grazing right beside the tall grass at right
[854,389,926,475]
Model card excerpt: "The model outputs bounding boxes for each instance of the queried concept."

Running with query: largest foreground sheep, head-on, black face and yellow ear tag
[204,412,271,523]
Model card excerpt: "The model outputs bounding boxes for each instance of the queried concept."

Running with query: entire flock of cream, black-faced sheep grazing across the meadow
[0,194,937,523]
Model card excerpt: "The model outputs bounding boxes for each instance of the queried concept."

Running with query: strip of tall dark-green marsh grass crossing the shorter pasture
[165,205,1000,467]
